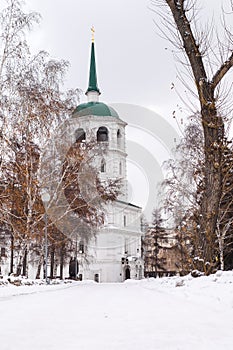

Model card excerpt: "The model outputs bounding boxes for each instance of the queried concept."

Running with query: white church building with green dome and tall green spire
[71,32,144,282]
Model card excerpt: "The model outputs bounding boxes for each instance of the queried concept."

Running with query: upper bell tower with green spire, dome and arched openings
[73,28,127,201]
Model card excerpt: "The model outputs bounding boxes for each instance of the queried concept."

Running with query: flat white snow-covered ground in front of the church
[0,271,233,350]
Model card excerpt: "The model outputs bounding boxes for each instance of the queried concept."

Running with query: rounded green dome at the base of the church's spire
[72,102,119,118]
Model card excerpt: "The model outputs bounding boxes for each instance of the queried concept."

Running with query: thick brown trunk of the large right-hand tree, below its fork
[200,89,224,274]
